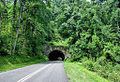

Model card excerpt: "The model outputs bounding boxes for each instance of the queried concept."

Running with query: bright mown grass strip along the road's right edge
[64,62,110,82]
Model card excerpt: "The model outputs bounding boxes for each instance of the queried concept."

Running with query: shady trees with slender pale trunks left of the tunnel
[0,0,54,56]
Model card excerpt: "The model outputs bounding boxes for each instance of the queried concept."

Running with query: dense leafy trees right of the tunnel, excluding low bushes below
[53,0,120,62]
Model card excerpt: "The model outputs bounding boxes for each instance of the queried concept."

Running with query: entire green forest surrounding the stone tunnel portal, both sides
[0,0,120,82]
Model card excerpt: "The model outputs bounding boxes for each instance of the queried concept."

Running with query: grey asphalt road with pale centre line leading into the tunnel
[0,61,68,82]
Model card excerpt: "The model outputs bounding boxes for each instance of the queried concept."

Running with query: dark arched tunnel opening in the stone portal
[48,50,65,61]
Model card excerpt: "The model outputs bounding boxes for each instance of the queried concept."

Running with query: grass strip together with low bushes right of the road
[64,57,120,82]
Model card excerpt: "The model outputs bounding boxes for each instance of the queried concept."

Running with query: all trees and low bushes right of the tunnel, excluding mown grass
[52,0,120,82]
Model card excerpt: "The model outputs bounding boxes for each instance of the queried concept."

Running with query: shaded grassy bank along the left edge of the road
[0,56,47,72]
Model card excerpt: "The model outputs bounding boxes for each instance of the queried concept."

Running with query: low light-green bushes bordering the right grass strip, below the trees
[82,56,120,82]
